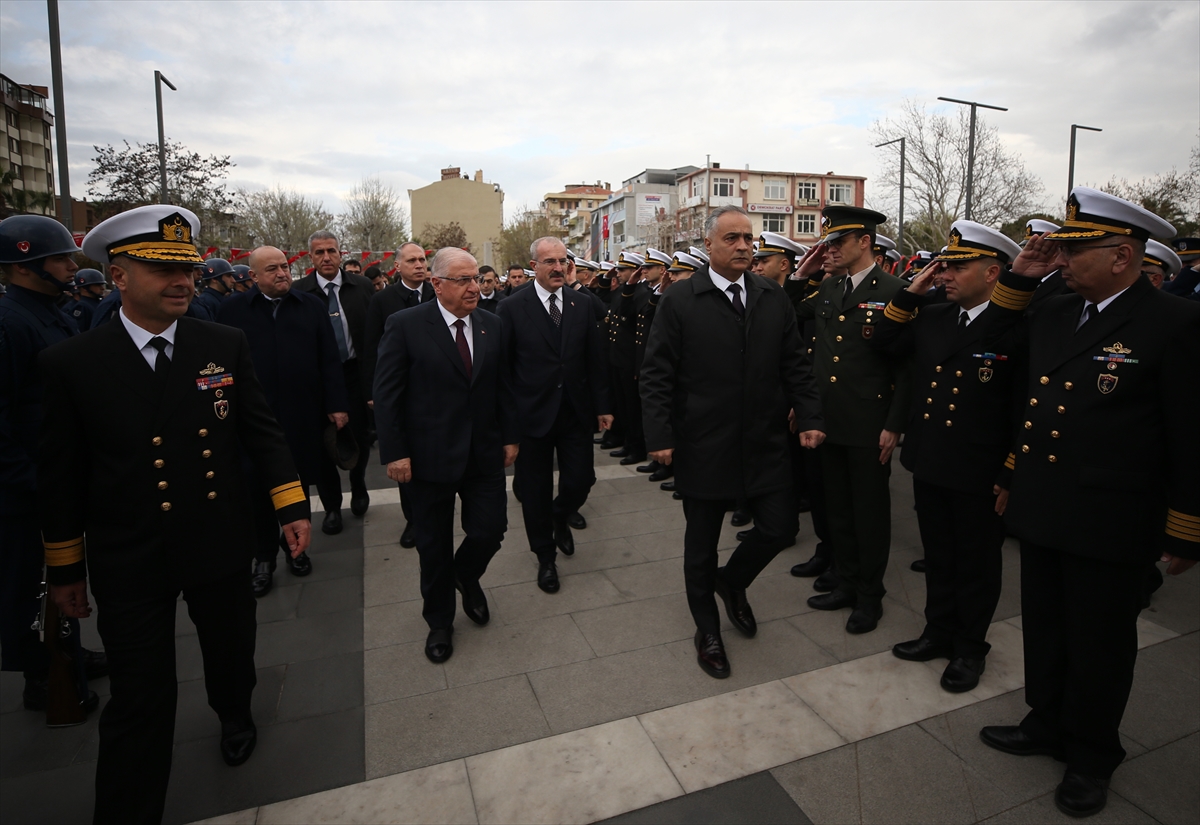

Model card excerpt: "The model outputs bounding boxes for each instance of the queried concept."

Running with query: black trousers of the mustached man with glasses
[515,400,596,561]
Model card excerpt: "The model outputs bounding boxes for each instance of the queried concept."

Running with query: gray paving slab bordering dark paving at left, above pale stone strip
[366,671,551,778]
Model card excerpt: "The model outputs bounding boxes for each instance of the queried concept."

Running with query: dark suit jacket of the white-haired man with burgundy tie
[374,300,520,483]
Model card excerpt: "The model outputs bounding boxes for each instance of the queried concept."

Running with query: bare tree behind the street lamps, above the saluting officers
[871,100,1043,254]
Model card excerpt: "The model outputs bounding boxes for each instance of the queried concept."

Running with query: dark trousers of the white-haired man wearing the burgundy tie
[406,470,509,630]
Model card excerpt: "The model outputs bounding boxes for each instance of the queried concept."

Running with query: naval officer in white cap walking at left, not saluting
[37,205,310,823]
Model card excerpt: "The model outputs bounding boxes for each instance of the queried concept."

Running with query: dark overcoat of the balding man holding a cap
[217,287,349,483]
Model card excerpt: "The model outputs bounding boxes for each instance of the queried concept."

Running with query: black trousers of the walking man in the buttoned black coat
[683,488,798,634]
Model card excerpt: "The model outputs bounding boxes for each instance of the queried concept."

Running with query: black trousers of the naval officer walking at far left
[95,570,256,825]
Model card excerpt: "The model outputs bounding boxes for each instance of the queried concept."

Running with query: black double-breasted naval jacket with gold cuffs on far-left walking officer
[37,318,308,595]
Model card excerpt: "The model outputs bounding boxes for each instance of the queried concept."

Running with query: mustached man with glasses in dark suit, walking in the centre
[496,237,612,594]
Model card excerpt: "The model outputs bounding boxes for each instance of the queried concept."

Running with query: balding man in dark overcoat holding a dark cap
[216,246,349,596]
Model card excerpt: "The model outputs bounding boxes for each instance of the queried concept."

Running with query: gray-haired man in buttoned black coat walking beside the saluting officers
[641,206,824,679]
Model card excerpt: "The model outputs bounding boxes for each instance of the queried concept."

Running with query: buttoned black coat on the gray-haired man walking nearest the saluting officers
[641,266,824,499]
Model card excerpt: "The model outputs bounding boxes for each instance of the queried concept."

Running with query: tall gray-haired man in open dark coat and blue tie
[293,229,376,535]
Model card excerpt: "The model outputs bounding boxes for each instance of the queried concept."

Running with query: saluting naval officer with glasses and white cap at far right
[980,187,1200,817]
